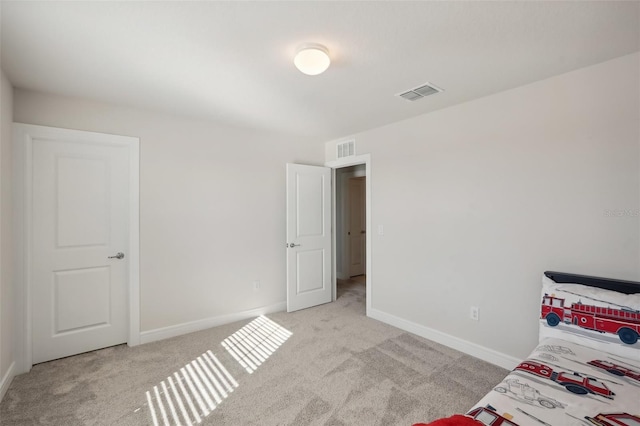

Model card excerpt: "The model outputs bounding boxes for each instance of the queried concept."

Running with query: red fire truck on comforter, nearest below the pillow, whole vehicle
[515,360,615,399]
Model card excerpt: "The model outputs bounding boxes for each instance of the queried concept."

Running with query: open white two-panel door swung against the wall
[287,164,332,312]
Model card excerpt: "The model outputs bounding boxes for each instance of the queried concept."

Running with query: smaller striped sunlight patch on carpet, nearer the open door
[222,315,293,374]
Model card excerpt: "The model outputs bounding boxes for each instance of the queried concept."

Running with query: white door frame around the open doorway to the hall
[324,154,373,316]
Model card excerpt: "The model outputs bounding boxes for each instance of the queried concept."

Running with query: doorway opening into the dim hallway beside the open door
[335,164,367,310]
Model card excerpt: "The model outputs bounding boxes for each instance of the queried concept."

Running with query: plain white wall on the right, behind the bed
[325,54,640,357]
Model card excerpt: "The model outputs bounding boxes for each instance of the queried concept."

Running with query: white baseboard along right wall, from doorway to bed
[369,308,522,370]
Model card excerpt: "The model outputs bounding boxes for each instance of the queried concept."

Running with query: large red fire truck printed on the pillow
[540,295,640,345]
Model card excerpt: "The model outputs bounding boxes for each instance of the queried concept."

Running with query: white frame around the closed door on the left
[12,123,140,374]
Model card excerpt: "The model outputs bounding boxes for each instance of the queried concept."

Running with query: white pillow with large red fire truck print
[539,275,640,360]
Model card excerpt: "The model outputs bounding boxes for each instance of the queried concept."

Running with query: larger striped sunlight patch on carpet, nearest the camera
[146,351,238,426]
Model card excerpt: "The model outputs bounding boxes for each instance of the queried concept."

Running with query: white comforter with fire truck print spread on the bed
[467,338,640,426]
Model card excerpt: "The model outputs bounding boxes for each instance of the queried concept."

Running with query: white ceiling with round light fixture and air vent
[0,0,640,140]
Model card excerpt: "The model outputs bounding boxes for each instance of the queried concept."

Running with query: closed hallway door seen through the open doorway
[348,177,367,277]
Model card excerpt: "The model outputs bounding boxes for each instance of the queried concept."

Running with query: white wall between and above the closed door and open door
[14,89,323,331]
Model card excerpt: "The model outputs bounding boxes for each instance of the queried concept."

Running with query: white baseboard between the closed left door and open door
[140,302,287,344]
